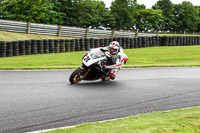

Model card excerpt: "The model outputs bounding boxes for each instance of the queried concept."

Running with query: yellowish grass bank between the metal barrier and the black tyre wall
[0,31,72,41]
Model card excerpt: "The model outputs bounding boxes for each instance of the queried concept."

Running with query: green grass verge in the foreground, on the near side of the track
[43,107,200,133]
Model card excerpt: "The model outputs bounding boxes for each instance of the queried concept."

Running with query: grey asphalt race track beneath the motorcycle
[0,67,200,133]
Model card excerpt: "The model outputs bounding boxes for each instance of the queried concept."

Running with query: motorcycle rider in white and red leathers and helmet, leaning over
[101,41,128,80]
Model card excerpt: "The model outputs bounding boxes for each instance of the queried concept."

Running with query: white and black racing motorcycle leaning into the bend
[69,48,110,84]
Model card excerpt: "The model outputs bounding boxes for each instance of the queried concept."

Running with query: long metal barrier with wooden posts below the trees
[0,19,157,38]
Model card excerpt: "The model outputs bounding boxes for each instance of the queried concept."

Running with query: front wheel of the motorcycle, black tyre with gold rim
[69,68,84,84]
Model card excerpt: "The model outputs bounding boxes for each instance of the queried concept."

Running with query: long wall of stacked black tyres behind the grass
[0,36,200,57]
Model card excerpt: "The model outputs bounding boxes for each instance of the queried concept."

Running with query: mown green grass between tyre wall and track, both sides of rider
[0,45,200,69]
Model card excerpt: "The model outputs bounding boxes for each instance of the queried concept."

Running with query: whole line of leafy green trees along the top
[0,0,200,32]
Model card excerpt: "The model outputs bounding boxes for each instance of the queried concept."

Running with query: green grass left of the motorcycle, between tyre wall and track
[0,52,85,69]
